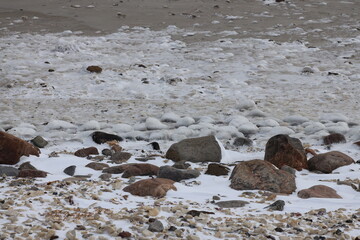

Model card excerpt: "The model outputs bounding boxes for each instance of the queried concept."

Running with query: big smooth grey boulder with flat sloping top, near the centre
[166,136,221,162]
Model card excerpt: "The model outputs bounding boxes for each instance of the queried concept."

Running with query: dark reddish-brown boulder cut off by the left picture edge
[0,131,40,165]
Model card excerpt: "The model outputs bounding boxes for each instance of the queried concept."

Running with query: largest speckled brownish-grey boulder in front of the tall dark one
[230,160,296,194]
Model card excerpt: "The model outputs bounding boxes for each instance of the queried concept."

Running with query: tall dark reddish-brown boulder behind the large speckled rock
[265,134,308,171]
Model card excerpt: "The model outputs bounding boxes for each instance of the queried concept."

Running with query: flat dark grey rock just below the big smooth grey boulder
[158,166,200,182]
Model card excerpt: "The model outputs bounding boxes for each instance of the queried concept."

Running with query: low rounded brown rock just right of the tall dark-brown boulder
[308,151,355,173]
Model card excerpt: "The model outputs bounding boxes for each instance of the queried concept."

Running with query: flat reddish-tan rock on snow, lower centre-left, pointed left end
[123,178,177,198]
